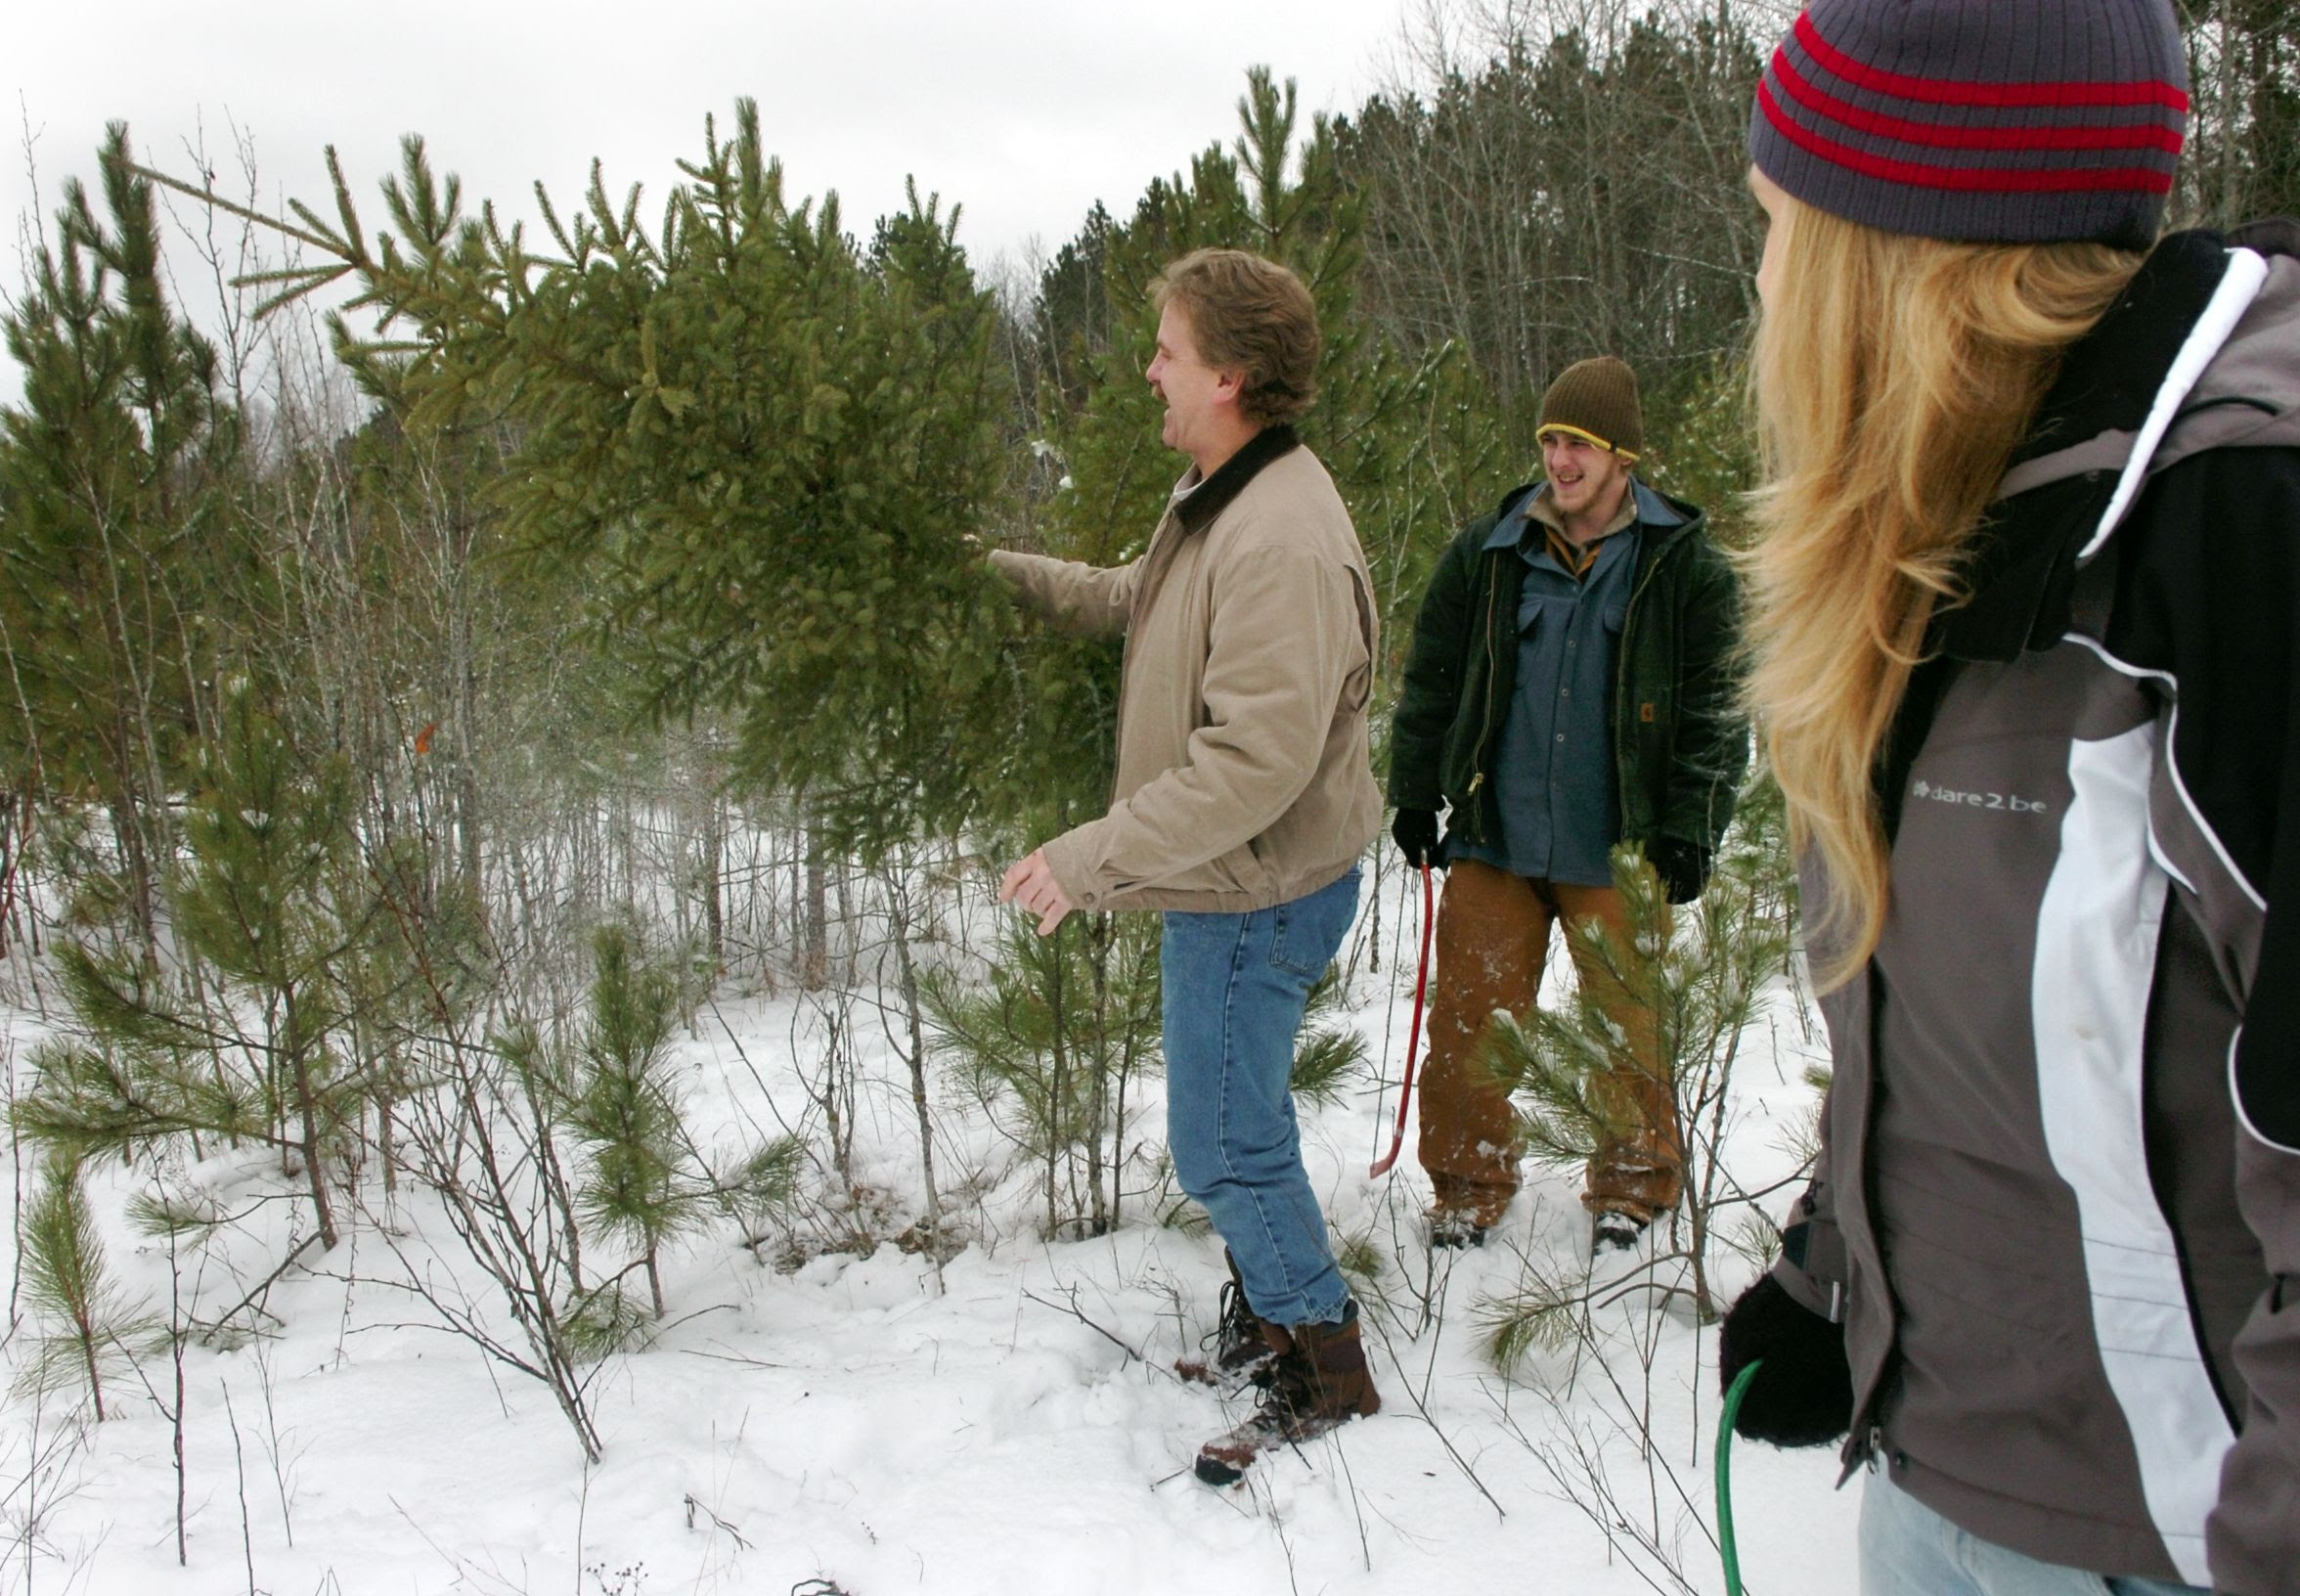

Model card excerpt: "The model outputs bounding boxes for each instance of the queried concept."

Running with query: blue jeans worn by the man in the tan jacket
[1162,867,1357,1325]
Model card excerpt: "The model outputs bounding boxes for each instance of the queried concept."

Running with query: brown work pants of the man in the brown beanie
[1419,860,1686,1225]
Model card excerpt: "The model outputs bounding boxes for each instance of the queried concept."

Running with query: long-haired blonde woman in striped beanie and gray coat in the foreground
[1720,0,2300,1596]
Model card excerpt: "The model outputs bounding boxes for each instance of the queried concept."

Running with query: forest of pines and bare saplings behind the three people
[0,0,2300,1591]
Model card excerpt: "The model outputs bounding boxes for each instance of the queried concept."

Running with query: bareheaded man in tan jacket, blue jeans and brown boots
[992,250,1383,1484]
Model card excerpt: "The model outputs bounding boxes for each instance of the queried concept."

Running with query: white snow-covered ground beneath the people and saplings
[0,873,1858,1596]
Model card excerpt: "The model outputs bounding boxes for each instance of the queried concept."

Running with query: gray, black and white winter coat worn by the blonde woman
[1780,225,2300,1596]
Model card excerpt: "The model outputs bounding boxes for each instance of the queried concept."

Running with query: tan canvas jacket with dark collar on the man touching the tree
[992,427,1383,913]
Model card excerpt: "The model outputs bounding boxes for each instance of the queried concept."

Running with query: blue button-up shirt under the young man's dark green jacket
[1453,485,1645,885]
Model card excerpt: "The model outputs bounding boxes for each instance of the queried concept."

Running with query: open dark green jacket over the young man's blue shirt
[1390,488,1748,868]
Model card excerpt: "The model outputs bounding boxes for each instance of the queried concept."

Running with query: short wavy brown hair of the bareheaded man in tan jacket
[1150,248,1320,425]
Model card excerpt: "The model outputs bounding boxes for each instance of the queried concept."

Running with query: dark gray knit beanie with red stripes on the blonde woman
[1748,0,2188,248]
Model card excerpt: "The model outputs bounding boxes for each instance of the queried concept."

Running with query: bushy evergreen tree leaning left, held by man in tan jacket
[138,101,1014,856]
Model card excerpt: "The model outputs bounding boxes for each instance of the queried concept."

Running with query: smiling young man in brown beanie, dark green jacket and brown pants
[1390,356,1748,1256]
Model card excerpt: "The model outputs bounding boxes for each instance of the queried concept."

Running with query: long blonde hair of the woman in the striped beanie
[1741,187,2142,989]
